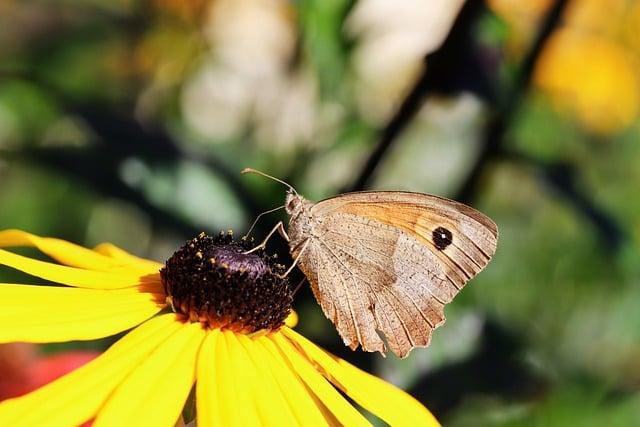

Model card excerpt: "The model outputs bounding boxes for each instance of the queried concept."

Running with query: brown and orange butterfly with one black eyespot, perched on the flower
[242,169,498,357]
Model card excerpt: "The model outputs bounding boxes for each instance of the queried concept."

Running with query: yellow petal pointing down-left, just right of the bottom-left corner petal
[94,323,206,427]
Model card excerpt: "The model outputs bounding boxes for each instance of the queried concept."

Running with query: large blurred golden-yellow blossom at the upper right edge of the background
[534,29,640,134]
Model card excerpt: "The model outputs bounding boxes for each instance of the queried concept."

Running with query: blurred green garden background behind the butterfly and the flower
[0,0,640,426]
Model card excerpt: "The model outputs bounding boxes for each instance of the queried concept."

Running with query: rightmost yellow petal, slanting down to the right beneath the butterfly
[280,327,440,426]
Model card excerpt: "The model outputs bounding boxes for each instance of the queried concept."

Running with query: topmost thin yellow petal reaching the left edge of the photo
[0,230,161,273]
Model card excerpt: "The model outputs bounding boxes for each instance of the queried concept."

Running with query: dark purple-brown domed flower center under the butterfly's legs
[160,232,292,333]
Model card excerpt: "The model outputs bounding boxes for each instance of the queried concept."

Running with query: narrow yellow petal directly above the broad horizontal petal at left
[0,249,160,289]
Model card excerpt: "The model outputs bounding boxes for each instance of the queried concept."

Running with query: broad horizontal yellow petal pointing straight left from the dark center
[0,283,164,342]
